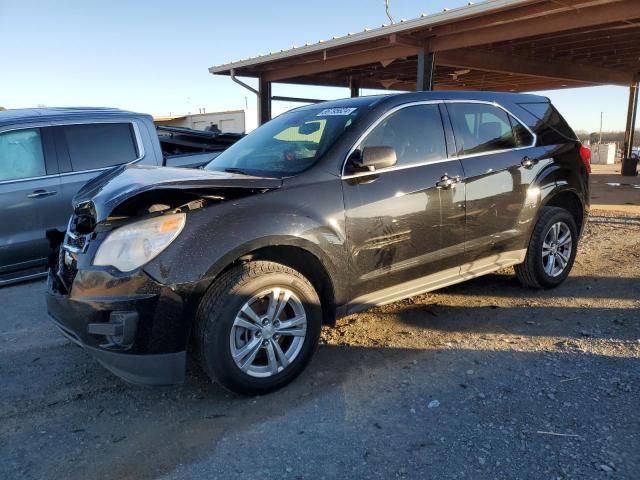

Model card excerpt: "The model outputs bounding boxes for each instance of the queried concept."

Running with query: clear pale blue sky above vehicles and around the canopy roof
[0,0,640,131]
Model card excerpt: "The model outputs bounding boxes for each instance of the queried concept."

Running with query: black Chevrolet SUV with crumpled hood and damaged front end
[47,92,590,394]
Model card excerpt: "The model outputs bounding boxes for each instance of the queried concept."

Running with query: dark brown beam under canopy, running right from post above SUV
[436,48,633,86]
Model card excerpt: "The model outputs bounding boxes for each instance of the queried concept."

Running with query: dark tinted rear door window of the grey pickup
[63,123,138,171]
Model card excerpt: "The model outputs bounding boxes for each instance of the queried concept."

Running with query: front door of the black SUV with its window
[342,103,465,296]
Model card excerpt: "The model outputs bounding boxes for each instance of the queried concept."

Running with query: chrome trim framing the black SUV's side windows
[340,99,538,180]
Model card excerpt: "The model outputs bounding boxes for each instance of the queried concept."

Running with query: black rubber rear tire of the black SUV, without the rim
[515,207,578,288]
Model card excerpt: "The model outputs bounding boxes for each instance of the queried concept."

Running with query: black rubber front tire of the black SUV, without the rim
[195,261,322,395]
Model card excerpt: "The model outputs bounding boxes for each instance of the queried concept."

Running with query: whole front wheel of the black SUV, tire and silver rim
[196,261,322,395]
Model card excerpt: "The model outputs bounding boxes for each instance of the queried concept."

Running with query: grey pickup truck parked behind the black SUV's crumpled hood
[0,108,241,285]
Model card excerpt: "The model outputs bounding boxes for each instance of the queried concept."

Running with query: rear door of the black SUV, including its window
[446,101,536,262]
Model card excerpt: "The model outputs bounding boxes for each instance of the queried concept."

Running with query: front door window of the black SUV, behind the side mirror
[360,105,447,166]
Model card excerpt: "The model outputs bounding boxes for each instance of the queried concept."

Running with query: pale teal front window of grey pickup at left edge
[0,128,47,182]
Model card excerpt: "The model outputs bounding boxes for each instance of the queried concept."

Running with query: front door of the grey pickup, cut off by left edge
[0,127,64,274]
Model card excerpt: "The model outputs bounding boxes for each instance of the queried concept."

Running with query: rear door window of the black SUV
[447,103,533,155]
